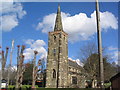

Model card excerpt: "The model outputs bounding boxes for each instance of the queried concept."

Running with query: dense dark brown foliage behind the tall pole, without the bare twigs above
[84,53,117,81]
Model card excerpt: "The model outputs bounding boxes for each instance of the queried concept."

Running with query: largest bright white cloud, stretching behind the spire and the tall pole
[36,11,118,42]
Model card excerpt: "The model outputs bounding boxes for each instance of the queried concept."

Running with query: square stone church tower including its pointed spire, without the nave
[46,5,68,88]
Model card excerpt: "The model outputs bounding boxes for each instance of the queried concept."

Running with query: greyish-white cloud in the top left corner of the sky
[0,0,26,32]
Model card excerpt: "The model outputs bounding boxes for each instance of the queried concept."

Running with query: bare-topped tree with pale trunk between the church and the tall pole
[80,42,99,88]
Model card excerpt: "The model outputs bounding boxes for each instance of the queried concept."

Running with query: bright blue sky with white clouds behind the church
[0,2,118,65]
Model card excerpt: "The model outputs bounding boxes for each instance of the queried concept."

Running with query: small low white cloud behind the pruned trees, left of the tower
[24,39,47,60]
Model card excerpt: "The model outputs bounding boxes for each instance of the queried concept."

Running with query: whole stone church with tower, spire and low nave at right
[46,5,85,88]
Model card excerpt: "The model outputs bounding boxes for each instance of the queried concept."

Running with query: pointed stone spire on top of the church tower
[54,5,63,31]
